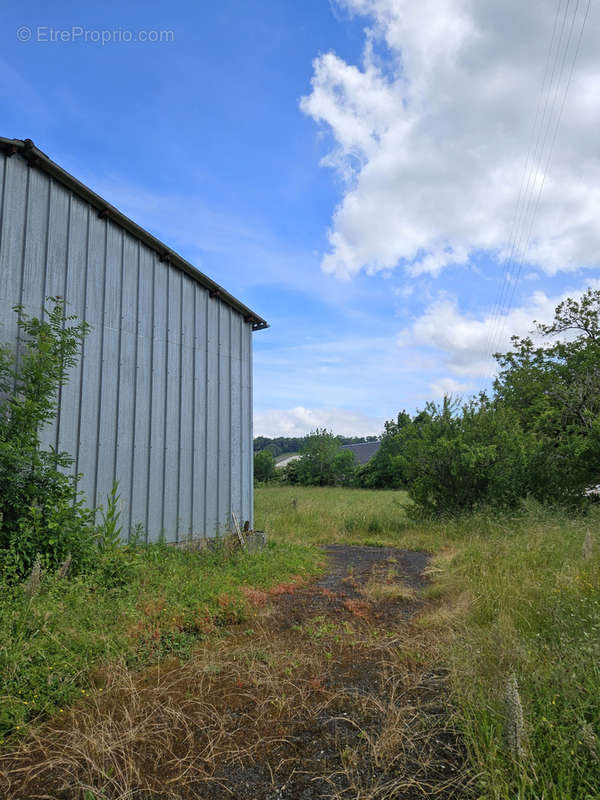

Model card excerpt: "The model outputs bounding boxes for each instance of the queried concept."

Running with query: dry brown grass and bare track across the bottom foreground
[0,580,460,800]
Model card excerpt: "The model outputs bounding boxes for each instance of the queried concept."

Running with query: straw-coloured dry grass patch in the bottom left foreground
[0,645,326,800]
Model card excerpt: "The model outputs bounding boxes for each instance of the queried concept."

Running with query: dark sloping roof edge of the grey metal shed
[0,136,269,331]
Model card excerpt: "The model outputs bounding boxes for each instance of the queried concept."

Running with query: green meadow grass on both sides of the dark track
[0,486,600,800]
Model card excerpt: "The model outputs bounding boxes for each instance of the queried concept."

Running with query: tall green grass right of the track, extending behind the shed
[256,488,600,800]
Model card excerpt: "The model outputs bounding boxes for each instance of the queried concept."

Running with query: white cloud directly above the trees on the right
[398,280,600,378]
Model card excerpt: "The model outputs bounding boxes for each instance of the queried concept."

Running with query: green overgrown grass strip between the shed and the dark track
[0,542,322,744]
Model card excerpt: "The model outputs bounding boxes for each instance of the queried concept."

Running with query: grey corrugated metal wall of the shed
[0,150,253,541]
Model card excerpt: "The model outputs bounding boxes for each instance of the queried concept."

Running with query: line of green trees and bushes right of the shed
[255,289,600,515]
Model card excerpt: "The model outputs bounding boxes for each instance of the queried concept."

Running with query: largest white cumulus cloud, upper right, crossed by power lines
[301,0,600,277]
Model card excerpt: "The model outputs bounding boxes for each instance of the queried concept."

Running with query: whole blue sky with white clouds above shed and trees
[0,0,600,435]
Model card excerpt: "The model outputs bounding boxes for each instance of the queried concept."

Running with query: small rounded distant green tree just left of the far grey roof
[295,428,356,486]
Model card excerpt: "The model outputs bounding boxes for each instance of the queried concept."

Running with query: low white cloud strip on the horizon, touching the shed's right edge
[254,406,384,437]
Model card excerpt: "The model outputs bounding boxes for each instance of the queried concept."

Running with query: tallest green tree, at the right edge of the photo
[494,289,600,504]
